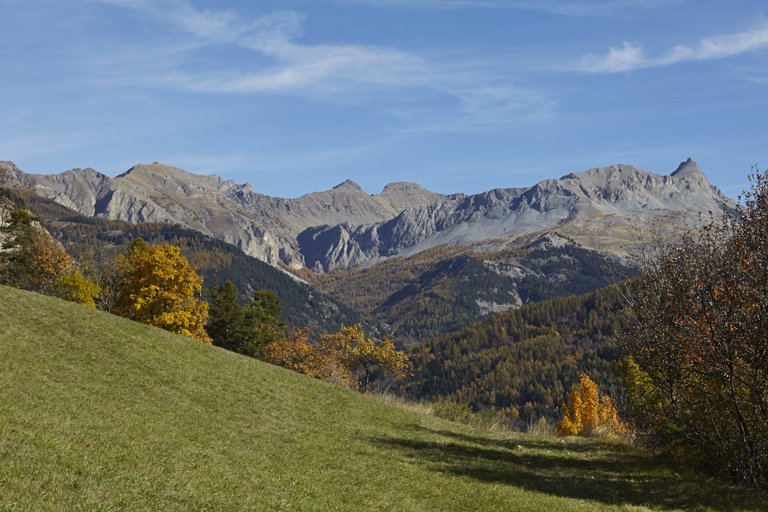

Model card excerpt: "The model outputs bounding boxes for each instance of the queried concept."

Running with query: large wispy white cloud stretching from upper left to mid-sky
[88,0,551,128]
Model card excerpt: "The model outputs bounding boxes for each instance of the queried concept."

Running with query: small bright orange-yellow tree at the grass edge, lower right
[556,373,632,438]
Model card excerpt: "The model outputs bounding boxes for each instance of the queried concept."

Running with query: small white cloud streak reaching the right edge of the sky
[577,24,768,73]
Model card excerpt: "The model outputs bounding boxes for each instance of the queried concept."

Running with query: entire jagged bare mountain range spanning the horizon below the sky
[0,159,734,272]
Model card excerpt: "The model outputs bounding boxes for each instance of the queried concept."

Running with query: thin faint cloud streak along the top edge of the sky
[333,0,681,16]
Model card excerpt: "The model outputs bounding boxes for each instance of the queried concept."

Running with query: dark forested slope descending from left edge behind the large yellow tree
[0,188,362,332]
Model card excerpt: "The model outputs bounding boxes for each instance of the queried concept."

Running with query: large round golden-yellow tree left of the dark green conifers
[114,238,211,343]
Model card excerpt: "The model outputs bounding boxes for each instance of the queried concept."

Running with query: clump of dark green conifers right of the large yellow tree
[205,280,286,357]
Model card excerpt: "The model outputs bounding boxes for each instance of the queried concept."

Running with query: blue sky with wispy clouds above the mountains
[0,0,768,198]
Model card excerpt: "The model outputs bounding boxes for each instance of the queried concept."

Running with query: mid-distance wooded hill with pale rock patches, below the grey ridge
[313,238,638,346]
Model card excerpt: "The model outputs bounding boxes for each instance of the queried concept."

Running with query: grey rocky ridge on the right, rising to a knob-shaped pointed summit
[298,159,734,271]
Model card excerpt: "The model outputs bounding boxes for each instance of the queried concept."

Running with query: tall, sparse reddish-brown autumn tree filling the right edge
[619,169,768,485]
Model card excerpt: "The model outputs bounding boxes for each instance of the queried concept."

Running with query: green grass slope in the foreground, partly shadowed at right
[0,287,768,512]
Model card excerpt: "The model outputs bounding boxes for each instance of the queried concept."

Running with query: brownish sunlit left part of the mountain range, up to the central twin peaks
[0,162,447,268]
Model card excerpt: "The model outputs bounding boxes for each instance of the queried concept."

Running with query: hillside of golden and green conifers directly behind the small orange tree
[397,287,627,424]
